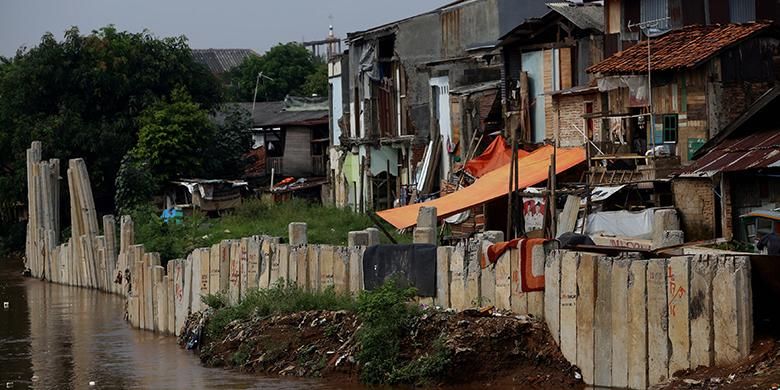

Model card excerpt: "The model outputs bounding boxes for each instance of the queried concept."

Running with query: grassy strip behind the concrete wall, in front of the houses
[132,200,411,261]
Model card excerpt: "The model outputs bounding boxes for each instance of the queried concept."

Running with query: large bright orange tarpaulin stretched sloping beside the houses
[377,145,585,229]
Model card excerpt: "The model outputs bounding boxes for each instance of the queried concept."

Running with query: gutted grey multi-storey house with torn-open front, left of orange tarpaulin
[329,0,546,210]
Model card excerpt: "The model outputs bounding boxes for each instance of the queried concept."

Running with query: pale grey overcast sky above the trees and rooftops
[0,0,449,57]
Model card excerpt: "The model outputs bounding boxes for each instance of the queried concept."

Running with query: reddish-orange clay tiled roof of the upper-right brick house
[587,22,770,74]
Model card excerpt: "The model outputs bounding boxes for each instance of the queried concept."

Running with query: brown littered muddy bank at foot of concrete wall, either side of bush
[180,311,583,389]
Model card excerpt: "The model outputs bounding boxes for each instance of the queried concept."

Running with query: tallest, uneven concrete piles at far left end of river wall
[25,141,126,294]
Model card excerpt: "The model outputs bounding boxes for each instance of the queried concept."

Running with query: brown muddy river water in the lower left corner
[0,258,354,390]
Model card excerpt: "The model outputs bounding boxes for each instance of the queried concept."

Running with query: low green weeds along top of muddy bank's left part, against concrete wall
[204,281,355,339]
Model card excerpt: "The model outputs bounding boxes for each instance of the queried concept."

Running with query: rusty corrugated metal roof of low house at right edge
[680,129,780,177]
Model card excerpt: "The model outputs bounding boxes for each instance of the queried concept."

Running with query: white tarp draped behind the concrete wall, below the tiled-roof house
[585,209,655,240]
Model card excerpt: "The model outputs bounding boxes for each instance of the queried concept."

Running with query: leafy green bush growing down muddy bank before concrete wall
[357,280,420,384]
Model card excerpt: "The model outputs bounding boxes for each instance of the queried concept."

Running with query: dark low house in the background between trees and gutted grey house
[238,96,329,180]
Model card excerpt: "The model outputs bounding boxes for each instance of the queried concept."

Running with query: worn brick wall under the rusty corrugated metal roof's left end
[672,178,717,241]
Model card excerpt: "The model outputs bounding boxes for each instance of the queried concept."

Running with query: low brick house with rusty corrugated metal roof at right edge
[672,86,780,242]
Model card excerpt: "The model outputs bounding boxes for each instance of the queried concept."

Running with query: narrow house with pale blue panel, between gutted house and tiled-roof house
[500,2,604,147]
